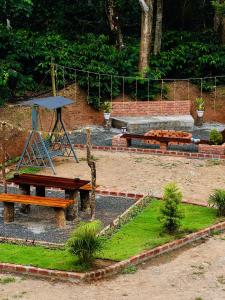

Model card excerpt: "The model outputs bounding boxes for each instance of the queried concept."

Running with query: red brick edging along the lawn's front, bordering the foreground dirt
[0,222,225,283]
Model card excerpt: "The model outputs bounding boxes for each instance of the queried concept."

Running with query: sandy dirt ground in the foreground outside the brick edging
[0,236,225,300]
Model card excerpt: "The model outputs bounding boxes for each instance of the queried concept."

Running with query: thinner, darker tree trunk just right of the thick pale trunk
[154,0,163,55]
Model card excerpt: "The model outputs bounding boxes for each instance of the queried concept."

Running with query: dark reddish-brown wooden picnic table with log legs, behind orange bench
[7,174,90,221]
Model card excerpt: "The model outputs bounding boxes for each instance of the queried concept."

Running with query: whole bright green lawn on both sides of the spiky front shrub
[0,200,220,271]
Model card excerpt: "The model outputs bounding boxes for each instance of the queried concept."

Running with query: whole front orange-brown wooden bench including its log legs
[0,194,75,228]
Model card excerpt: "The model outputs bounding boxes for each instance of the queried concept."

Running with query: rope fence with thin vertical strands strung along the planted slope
[55,64,225,112]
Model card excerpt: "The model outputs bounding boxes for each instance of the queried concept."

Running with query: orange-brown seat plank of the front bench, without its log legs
[0,194,74,208]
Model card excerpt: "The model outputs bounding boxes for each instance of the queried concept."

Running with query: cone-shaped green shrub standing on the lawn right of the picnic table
[159,183,183,234]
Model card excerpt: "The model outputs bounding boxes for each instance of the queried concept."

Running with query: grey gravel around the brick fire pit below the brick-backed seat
[71,123,225,152]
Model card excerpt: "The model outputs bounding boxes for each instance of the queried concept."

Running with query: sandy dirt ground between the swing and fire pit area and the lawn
[42,150,225,201]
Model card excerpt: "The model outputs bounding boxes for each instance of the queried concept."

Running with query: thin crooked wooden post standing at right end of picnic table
[86,128,96,220]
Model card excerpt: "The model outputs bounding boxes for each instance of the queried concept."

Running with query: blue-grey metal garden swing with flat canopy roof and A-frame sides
[17,96,78,174]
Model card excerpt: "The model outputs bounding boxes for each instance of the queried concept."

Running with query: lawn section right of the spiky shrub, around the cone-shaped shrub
[99,200,217,261]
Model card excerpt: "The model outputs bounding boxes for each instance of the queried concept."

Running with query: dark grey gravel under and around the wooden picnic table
[0,188,134,243]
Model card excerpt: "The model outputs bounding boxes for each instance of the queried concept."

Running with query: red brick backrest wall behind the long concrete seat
[111,100,191,117]
